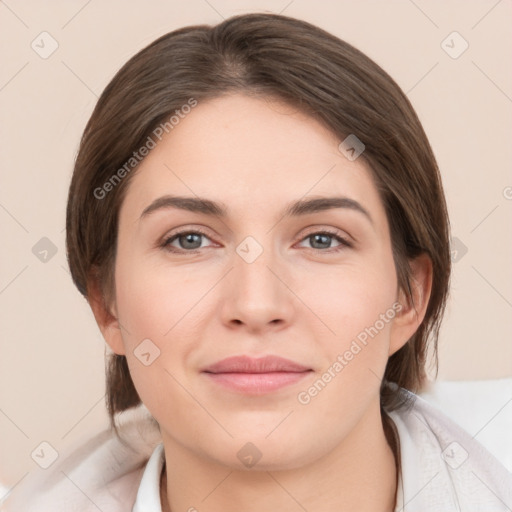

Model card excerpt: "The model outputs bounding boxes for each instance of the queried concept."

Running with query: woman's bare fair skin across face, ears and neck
[90,94,432,512]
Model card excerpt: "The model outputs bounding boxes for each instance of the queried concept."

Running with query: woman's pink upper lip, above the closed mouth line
[202,356,311,373]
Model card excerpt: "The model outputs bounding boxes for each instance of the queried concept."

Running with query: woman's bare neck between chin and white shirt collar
[161,407,397,512]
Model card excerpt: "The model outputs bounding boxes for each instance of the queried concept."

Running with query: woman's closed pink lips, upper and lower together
[203,356,311,395]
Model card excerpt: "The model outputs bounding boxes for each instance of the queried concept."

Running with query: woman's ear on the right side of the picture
[389,253,433,356]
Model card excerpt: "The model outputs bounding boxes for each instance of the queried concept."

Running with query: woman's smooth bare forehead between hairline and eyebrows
[123,94,383,228]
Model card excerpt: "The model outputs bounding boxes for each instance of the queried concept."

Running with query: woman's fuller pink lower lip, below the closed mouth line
[204,371,311,395]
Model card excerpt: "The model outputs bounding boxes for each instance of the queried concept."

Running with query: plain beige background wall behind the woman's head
[0,0,512,485]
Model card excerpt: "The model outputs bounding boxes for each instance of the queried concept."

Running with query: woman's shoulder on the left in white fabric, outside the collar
[0,406,161,512]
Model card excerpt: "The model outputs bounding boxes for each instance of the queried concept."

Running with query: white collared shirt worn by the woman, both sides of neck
[0,390,512,512]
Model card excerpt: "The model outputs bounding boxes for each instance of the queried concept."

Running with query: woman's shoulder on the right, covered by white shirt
[389,389,512,512]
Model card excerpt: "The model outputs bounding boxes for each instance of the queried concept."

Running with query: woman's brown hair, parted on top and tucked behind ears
[66,14,451,448]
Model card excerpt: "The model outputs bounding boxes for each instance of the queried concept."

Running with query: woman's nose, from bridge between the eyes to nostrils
[222,241,296,332]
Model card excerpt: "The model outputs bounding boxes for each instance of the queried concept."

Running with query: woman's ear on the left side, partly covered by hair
[87,272,125,355]
